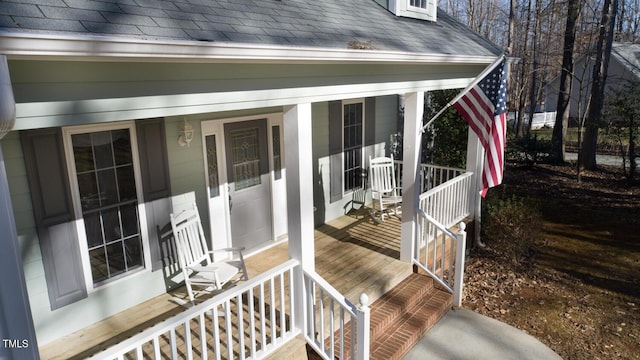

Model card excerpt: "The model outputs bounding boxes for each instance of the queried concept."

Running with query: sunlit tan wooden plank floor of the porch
[40,210,412,359]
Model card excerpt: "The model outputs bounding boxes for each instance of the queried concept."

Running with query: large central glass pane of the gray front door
[230,128,261,191]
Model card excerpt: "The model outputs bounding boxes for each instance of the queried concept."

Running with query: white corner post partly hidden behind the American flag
[467,128,484,246]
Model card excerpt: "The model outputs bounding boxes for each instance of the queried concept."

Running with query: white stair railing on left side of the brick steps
[304,272,370,360]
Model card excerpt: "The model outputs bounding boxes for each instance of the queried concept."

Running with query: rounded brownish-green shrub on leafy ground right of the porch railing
[481,193,542,265]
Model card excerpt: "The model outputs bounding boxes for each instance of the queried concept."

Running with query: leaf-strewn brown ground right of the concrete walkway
[463,165,640,359]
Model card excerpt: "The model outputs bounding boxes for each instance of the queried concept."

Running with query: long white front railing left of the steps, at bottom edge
[95,260,300,359]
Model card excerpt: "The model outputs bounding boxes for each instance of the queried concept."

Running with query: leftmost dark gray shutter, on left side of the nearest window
[20,128,87,310]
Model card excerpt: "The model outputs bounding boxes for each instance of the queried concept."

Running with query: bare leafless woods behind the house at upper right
[439,0,640,178]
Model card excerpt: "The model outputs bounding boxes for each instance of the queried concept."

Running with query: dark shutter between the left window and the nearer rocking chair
[136,118,171,271]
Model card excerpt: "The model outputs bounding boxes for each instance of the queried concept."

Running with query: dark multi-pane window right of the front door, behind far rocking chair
[342,102,364,192]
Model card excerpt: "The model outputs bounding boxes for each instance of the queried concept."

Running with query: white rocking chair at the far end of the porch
[369,156,402,222]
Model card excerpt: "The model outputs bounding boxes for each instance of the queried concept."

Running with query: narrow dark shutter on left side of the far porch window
[329,101,342,203]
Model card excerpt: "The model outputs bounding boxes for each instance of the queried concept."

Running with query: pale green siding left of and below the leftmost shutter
[0,131,170,345]
